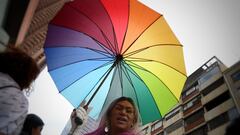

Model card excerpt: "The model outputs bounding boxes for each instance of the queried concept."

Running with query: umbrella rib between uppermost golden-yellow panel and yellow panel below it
[124,43,183,57]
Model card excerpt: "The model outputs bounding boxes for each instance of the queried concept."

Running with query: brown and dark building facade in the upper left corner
[0,0,69,69]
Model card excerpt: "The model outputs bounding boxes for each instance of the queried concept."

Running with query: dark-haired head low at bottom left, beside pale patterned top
[20,114,44,135]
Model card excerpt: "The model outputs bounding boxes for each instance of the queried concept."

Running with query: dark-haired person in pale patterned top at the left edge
[0,45,40,135]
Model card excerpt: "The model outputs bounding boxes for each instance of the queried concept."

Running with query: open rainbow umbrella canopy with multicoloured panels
[44,0,186,124]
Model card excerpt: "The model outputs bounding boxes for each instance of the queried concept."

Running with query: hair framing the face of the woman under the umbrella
[105,97,139,125]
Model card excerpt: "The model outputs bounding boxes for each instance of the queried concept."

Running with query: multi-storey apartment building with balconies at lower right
[140,57,240,135]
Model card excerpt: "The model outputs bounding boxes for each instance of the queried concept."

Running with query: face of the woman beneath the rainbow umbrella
[110,101,135,131]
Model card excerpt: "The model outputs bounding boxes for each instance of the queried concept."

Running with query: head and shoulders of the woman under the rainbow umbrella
[69,97,140,135]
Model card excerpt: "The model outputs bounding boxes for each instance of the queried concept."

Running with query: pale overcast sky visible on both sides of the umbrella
[29,0,240,135]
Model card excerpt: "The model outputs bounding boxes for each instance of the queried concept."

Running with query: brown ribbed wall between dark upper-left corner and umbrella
[16,0,66,68]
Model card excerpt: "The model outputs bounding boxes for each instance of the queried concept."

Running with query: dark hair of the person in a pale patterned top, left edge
[0,45,40,90]
